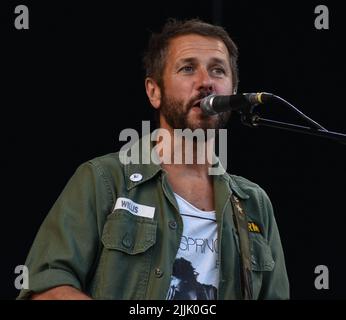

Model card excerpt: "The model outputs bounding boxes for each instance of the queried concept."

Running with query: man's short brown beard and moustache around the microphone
[161,90,231,133]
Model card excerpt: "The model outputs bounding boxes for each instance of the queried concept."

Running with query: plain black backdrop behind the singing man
[0,0,346,299]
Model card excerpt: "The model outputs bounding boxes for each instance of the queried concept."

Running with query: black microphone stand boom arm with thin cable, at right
[241,95,346,144]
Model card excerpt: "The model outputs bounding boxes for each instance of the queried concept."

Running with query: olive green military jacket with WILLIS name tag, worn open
[18,138,289,299]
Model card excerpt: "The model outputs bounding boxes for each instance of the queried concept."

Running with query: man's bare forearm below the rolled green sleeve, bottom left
[31,286,92,300]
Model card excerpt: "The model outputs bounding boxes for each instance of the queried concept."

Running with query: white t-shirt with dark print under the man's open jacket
[167,193,219,300]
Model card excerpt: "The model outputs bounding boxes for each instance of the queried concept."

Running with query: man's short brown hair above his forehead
[143,18,239,89]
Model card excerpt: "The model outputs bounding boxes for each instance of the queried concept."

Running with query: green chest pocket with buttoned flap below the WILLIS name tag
[95,209,157,300]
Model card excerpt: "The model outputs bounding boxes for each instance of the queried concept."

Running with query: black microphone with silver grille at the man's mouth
[200,92,274,115]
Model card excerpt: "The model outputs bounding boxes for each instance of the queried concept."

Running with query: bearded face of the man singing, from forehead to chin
[160,35,233,130]
